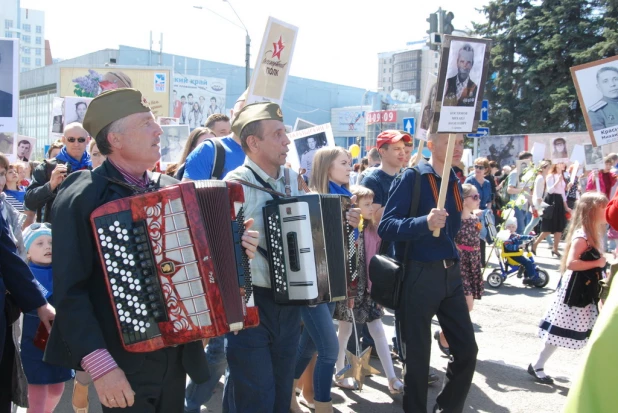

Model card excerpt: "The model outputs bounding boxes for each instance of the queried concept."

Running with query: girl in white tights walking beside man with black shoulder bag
[334,186,403,394]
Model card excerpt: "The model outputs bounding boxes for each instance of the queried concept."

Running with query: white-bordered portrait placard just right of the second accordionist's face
[287,123,335,177]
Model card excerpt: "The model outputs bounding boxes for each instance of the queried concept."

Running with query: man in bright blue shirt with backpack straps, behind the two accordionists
[182,93,246,413]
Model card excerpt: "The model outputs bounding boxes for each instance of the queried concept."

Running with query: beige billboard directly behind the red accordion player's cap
[58,66,171,116]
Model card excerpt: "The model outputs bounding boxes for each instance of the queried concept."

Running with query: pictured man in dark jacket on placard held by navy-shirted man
[442,43,478,106]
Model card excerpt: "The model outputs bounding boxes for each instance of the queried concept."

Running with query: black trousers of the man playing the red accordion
[102,347,186,413]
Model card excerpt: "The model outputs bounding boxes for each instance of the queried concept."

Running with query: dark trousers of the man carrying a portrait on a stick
[398,261,478,413]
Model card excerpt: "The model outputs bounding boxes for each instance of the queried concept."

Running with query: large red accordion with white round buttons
[90,181,259,352]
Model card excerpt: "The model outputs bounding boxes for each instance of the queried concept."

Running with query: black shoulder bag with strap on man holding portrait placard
[369,167,421,310]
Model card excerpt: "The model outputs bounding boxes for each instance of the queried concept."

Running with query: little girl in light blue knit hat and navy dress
[21,223,73,413]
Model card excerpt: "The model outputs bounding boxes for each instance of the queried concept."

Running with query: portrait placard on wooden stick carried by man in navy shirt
[431,35,491,133]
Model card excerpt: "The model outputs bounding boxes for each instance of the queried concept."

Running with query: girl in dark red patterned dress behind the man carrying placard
[434,184,484,356]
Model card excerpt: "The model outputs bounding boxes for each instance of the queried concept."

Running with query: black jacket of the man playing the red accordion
[44,161,209,383]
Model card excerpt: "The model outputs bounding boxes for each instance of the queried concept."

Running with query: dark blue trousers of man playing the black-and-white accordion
[223,287,301,413]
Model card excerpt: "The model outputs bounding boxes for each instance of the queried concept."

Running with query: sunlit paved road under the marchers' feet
[20,243,581,413]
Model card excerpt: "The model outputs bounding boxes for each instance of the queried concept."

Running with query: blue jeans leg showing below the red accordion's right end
[185,336,227,413]
